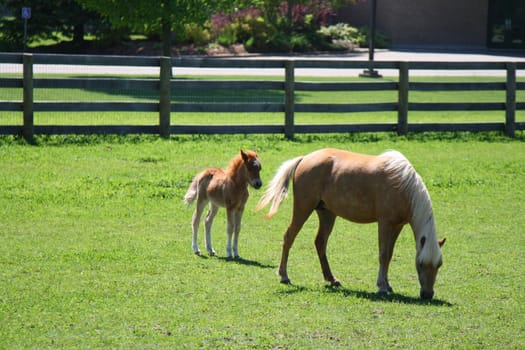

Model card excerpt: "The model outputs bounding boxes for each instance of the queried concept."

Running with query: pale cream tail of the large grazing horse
[256,156,303,218]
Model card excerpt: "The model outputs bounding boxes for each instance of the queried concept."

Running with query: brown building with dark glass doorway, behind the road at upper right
[338,0,525,50]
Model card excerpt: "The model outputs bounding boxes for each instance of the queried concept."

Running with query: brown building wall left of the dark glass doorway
[338,0,488,48]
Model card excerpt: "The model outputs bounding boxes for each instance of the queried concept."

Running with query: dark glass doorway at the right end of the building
[487,0,525,49]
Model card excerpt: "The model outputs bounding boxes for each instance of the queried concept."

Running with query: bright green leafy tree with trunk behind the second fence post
[76,0,242,56]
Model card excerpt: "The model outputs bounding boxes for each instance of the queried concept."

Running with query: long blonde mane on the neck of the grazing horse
[382,151,441,266]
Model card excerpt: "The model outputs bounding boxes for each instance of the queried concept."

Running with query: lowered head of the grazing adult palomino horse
[416,236,446,300]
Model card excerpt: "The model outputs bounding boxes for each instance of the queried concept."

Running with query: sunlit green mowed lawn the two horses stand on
[0,132,525,349]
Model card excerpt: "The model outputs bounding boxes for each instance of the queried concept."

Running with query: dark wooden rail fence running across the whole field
[0,53,525,139]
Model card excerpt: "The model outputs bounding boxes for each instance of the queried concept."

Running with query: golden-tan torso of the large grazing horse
[294,148,409,223]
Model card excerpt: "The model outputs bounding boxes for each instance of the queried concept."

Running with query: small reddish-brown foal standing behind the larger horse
[184,150,262,259]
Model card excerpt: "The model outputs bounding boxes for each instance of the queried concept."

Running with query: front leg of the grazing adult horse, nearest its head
[377,222,403,294]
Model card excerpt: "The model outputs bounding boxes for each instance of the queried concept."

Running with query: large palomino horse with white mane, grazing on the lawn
[257,149,444,299]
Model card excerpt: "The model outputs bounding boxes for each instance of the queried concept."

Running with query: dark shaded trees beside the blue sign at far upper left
[0,0,99,49]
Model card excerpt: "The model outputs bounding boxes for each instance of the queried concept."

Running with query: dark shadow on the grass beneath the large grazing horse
[280,284,454,307]
